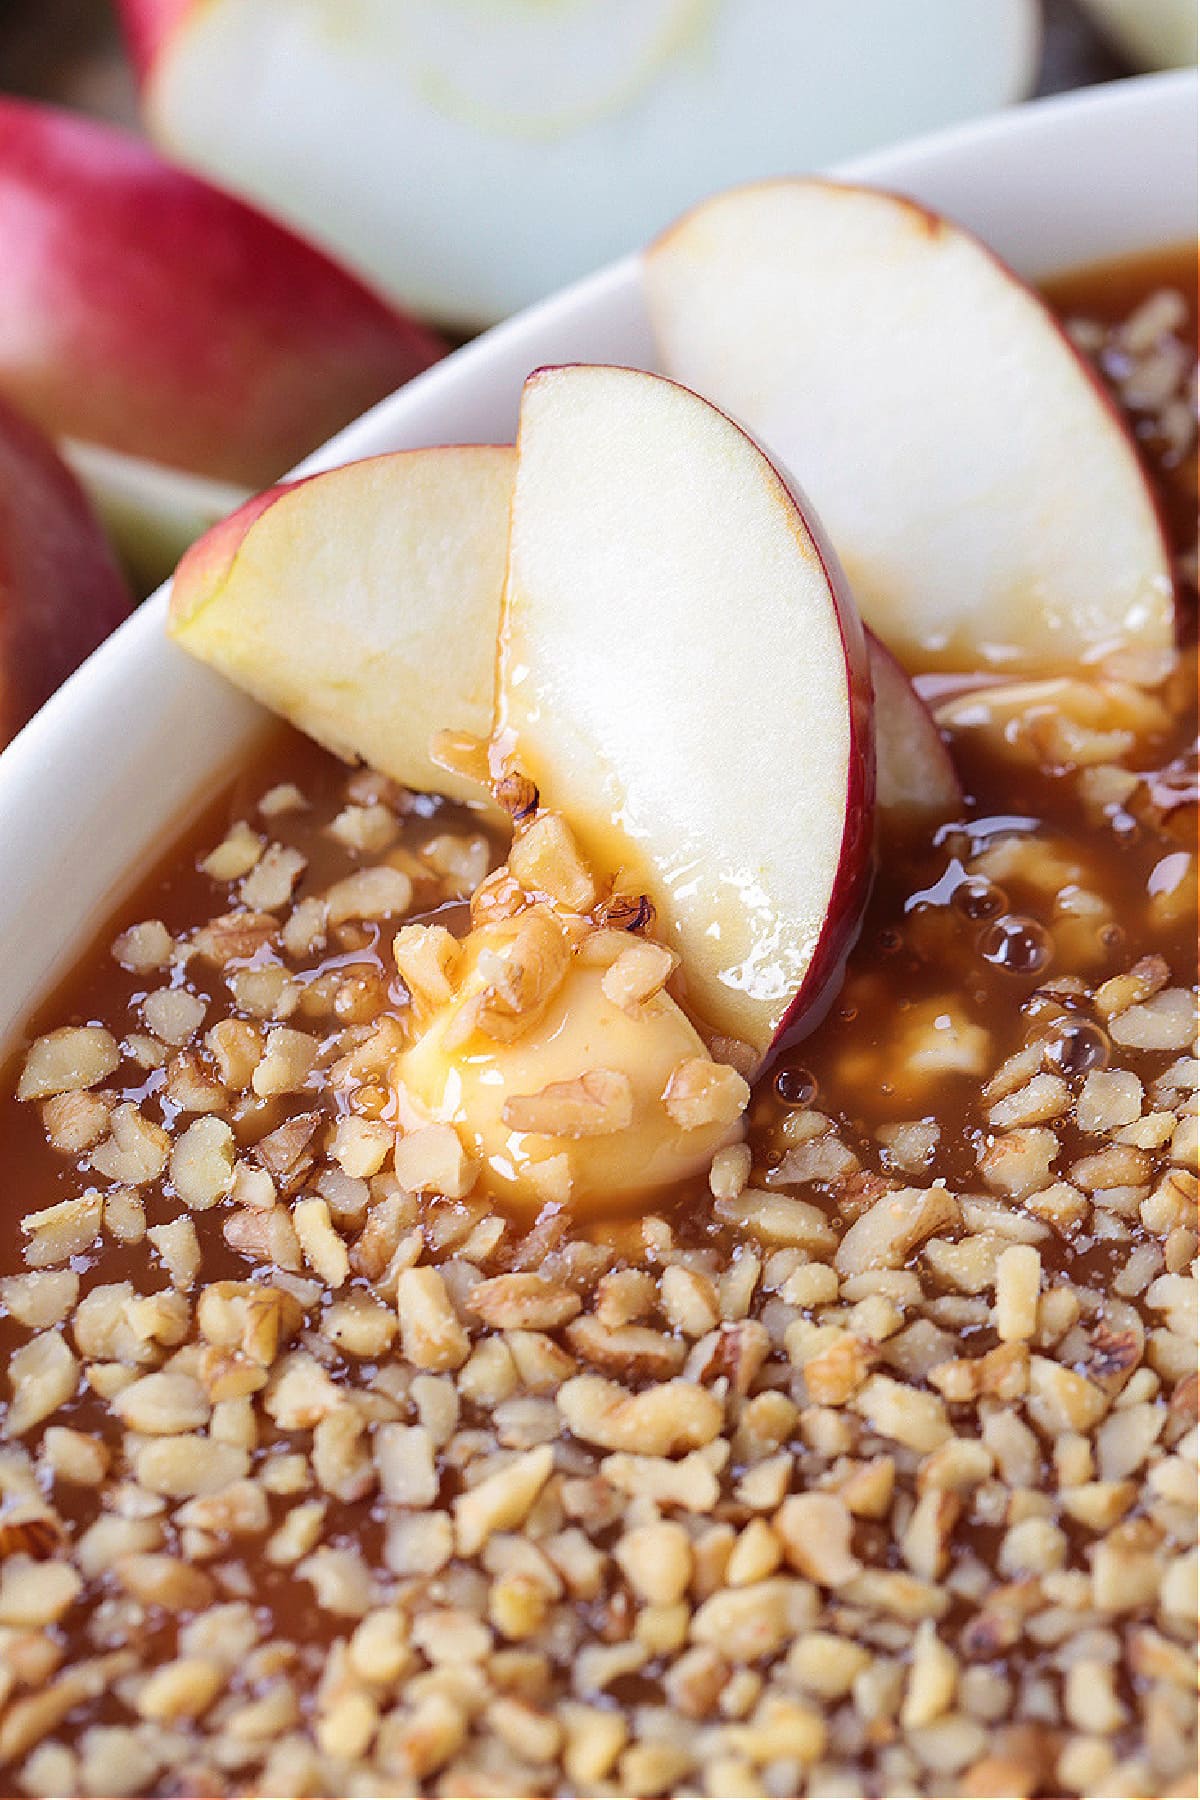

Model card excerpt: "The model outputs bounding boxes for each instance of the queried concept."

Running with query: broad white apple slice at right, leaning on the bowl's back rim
[646,180,1175,671]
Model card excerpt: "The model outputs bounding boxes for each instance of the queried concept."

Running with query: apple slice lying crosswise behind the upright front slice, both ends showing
[171,435,963,835]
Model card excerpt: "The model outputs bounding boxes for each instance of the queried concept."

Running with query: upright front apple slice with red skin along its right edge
[497,367,874,1057]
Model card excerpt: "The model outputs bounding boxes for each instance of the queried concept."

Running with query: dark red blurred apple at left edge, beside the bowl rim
[0,405,131,745]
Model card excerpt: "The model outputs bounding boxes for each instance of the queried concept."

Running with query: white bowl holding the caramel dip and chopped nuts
[0,74,1196,1044]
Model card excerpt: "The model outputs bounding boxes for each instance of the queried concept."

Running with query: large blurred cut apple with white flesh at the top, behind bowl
[119,0,1038,329]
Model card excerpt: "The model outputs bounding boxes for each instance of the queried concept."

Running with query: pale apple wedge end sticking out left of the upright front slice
[169,445,515,801]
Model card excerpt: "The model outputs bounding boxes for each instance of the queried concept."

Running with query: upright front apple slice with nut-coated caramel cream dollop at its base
[396,367,874,1211]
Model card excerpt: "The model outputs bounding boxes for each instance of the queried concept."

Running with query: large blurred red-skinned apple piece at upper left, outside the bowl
[0,99,444,488]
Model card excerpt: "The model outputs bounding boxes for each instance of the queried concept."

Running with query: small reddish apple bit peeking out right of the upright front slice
[867,632,963,828]
